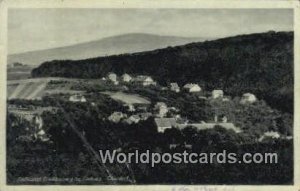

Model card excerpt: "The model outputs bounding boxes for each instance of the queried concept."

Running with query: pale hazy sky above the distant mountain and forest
[8,9,293,54]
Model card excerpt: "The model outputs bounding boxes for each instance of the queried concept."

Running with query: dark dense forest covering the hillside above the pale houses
[32,31,293,113]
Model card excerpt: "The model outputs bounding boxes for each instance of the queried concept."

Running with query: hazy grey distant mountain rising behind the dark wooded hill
[8,33,206,65]
